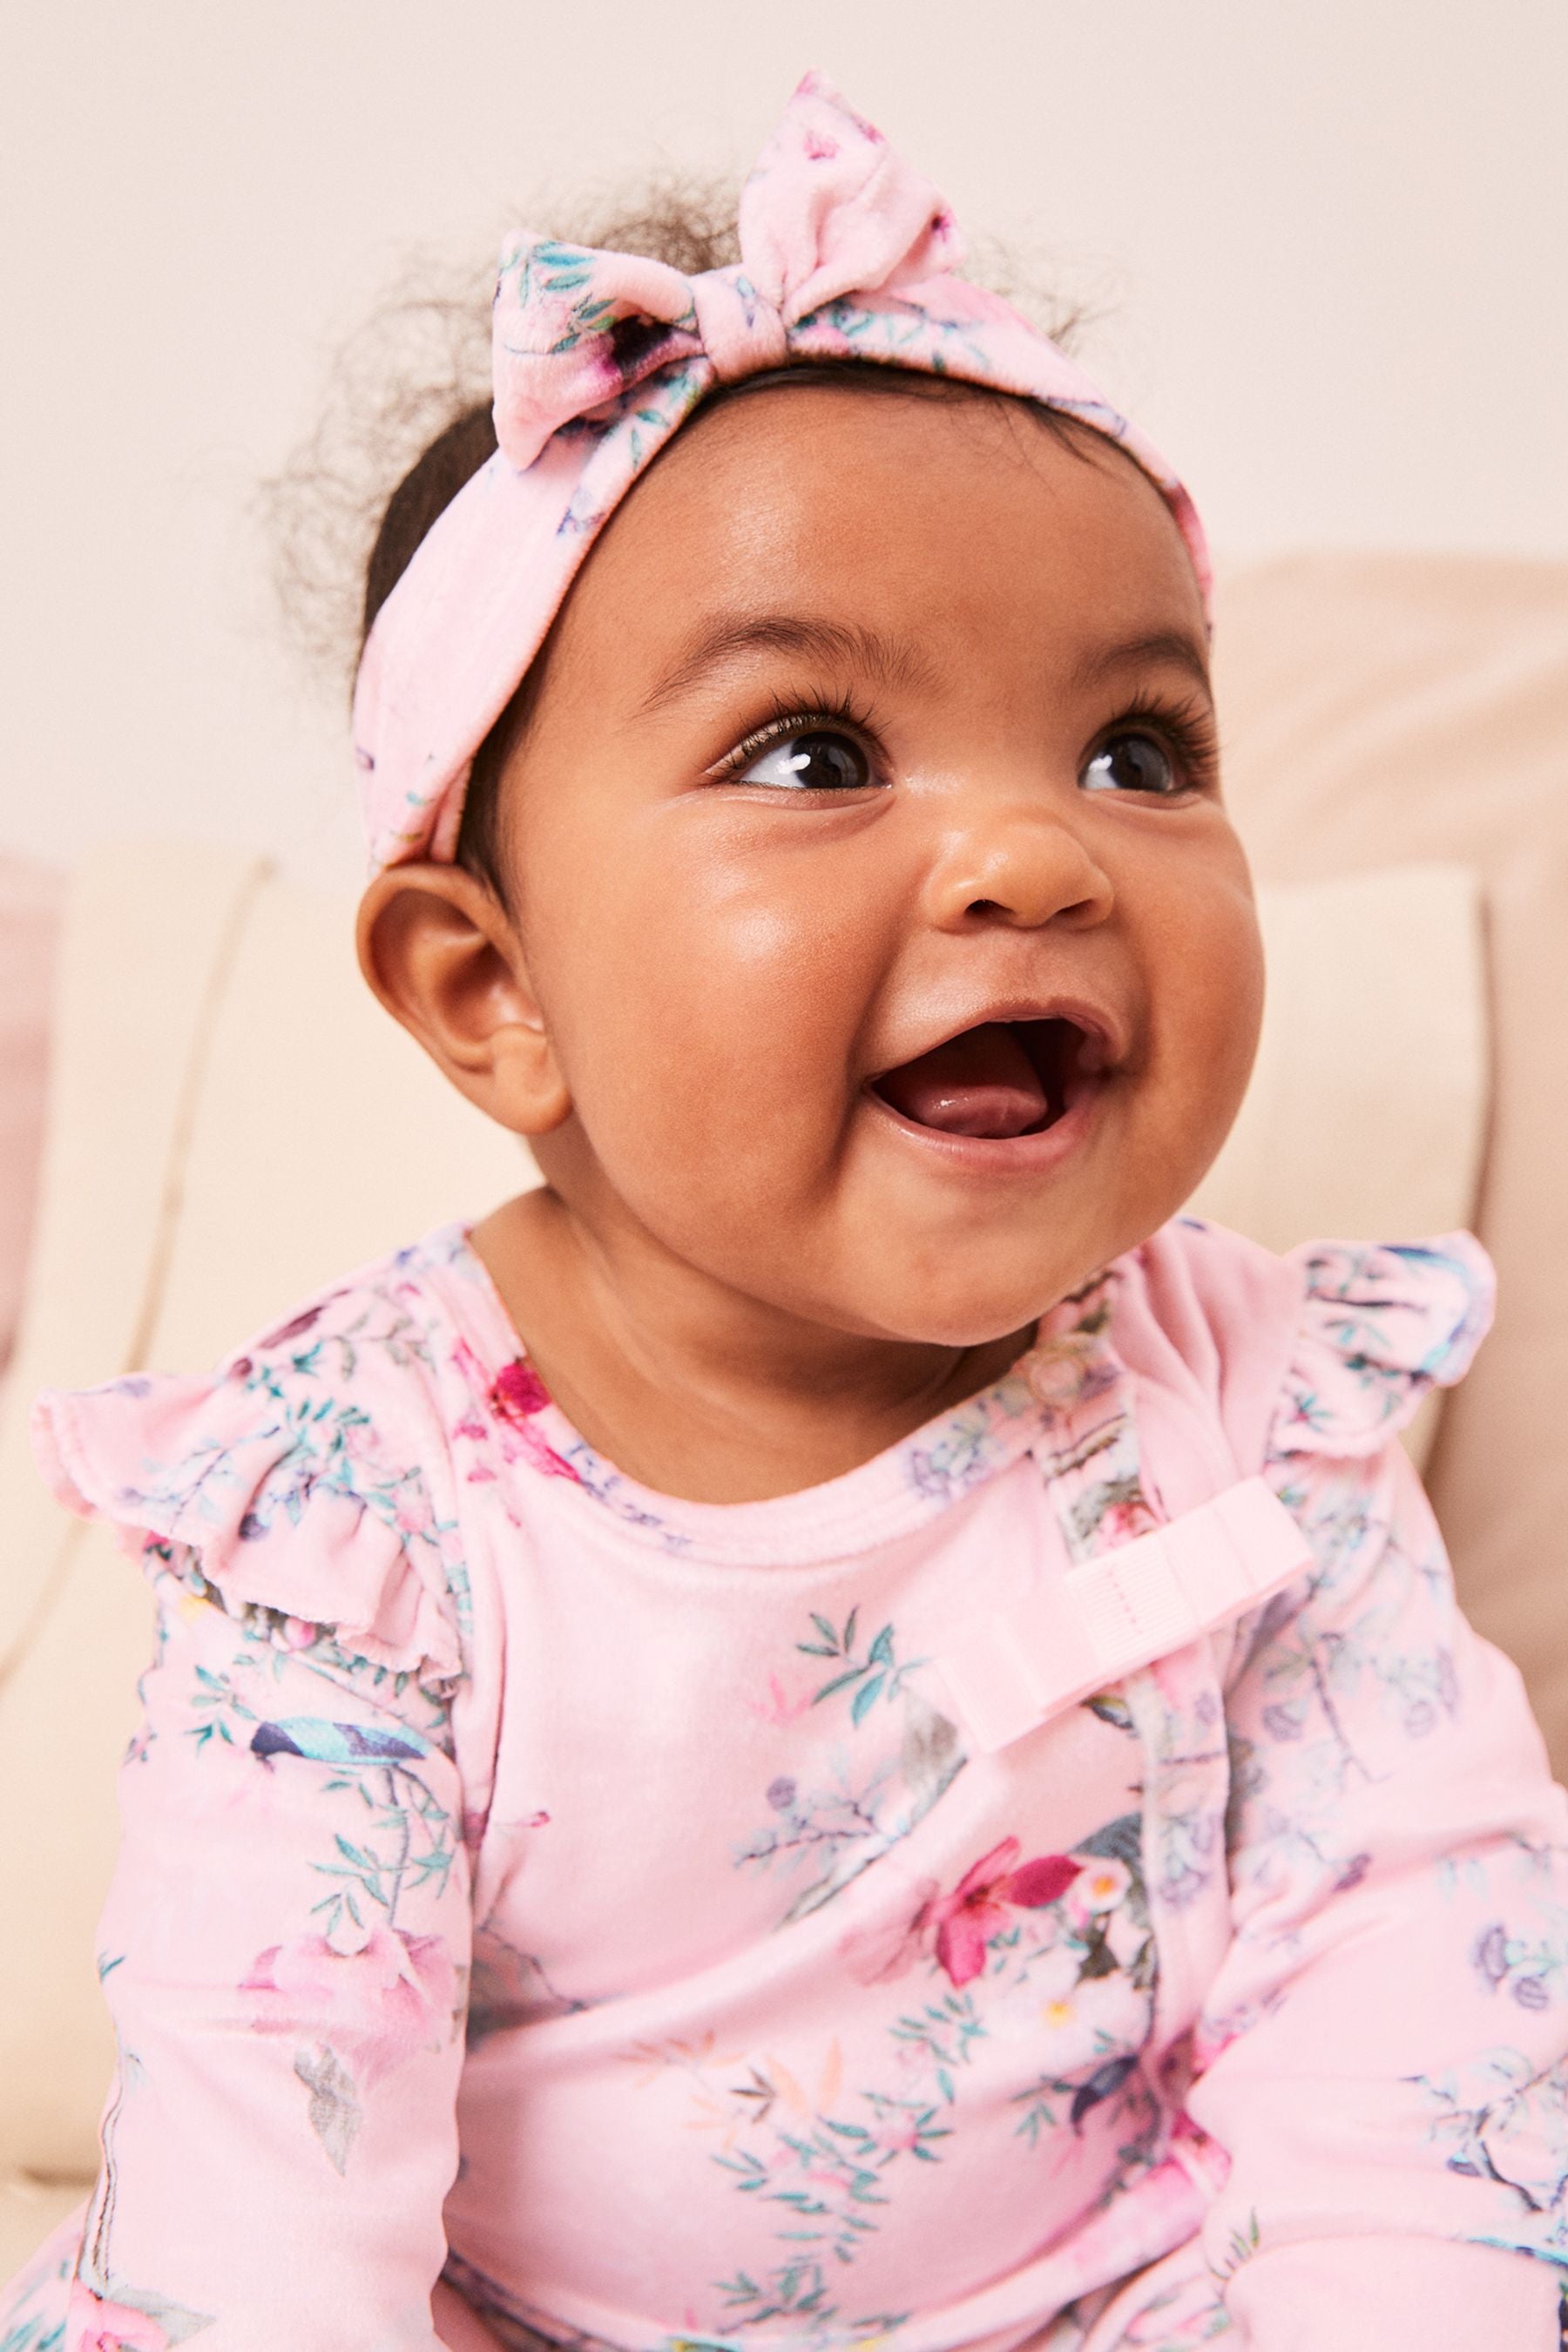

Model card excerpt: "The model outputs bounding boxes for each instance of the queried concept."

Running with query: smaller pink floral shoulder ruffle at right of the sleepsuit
[1269,1233,1495,1458]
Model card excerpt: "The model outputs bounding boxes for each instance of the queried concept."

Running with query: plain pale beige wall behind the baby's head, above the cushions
[0,0,1568,880]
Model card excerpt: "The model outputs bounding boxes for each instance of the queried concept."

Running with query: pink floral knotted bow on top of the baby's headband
[494,73,962,466]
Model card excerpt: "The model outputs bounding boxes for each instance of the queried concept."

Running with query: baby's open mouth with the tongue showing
[872,1021,1105,1143]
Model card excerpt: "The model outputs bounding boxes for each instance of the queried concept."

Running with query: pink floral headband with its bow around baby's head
[353,73,1208,870]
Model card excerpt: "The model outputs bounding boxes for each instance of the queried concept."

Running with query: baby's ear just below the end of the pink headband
[357,863,571,1136]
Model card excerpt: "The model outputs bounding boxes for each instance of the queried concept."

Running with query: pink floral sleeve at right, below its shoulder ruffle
[1190,1444,1568,2352]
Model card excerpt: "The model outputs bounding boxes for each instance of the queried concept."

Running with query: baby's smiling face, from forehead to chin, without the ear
[501,386,1262,1345]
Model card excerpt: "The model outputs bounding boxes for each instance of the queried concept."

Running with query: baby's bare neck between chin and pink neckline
[472,1190,1030,1503]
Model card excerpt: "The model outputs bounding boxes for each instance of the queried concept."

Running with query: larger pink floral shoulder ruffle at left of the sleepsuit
[33,1280,463,1686]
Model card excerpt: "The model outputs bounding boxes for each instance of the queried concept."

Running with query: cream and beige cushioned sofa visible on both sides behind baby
[0,558,1568,2279]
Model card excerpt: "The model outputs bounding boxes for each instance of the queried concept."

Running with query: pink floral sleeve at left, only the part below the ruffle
[66,1545,470,2352]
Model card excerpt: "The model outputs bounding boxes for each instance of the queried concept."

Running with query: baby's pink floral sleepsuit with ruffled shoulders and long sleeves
[0,1220,1568,2352]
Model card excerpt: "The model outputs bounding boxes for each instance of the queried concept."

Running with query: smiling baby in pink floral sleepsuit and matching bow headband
[0,78,1568,2352]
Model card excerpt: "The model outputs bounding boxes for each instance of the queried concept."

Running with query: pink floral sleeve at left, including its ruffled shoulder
[23,1291,470,2352]
